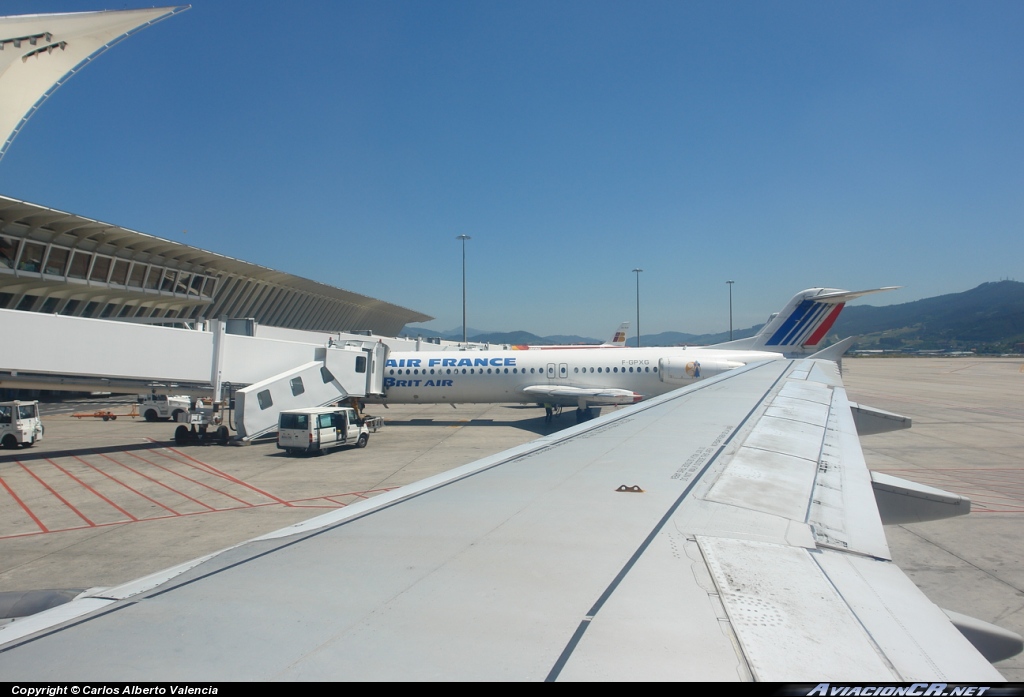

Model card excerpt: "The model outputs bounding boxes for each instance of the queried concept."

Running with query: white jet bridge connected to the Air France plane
[0,310,388,440]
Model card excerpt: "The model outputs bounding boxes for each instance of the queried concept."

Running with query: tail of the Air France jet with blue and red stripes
[714,286,899,354]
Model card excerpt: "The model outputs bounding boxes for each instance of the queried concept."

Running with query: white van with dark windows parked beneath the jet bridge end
[278,406,370,455]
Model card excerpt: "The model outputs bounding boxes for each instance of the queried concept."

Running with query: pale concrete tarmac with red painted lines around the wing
[0,357,1024,682]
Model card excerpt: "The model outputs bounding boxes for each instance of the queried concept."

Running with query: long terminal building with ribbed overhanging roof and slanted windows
[0,197,431,336]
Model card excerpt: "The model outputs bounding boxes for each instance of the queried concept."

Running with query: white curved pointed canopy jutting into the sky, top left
[0,5,189,158]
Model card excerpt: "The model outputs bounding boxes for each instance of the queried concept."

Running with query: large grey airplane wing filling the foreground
[0,359,1019,683]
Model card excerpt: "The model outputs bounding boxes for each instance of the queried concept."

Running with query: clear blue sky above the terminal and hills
[0,0,1024,337]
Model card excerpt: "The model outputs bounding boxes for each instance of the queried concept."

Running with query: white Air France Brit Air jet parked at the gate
[382,288,892,422]
